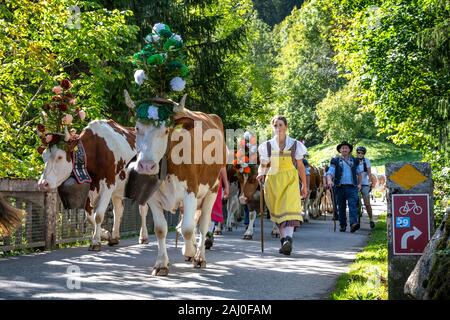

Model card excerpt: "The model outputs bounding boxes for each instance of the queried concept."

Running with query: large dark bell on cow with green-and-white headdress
[125,169,160,205]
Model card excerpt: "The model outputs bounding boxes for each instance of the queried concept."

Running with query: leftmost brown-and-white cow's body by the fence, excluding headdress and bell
[38,120,148,251]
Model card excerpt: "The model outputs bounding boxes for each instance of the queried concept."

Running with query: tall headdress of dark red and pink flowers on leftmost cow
[37,79,86,153]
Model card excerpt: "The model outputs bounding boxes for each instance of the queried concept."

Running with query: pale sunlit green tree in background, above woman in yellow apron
[274,0,345,145]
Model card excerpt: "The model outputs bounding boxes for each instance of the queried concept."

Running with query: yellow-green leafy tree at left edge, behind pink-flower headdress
[0,0,137,178]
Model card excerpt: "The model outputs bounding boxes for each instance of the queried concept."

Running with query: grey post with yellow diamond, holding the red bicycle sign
[386,162,434,300]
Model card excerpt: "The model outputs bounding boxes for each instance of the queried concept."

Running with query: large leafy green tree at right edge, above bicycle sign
[333,0,450,220]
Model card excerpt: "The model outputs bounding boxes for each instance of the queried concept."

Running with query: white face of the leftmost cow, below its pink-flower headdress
[38,146,72,190]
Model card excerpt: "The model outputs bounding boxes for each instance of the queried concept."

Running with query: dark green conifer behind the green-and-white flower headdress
[96,0,253,126]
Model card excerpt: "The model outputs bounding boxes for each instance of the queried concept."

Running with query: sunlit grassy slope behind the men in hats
[308,139,421,174]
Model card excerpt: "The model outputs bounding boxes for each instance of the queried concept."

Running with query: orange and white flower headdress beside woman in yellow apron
[233,131,258,174]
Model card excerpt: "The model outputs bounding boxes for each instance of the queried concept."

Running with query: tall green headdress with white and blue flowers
[133,23,189,126]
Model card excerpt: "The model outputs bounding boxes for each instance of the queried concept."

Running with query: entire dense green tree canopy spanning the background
[0,0,450,220]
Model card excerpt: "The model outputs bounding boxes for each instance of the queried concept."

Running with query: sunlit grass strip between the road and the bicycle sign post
[330,214,388,300]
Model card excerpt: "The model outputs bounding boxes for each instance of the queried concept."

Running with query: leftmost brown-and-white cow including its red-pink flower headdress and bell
[37,79,148,251]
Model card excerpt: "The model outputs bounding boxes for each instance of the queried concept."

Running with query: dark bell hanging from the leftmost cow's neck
[58,177,91,209]
